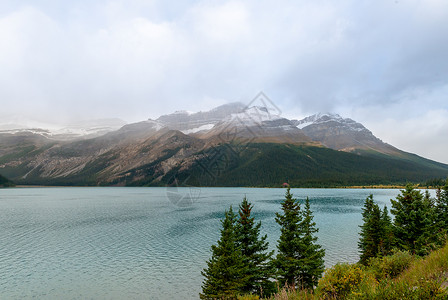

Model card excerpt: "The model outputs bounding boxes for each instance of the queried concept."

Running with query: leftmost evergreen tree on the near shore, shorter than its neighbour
[199,207,246,299]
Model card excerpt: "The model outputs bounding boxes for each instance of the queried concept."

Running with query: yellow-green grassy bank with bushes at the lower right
[238,244,448,300]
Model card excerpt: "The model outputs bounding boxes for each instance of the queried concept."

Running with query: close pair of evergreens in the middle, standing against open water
[274,188,324,288]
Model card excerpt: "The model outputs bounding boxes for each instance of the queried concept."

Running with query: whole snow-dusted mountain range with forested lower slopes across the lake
[0,103,448,187]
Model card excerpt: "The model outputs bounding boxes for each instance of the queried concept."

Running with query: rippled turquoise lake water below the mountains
[0,188,416,299]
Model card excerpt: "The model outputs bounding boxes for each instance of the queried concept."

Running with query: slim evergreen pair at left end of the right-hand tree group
[358,195,393,264]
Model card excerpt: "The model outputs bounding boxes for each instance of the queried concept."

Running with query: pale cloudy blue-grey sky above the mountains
[0,0,448,163]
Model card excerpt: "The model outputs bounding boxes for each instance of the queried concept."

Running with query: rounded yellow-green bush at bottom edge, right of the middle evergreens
[316,263,367,299]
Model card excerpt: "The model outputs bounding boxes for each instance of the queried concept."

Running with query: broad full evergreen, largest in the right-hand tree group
[391,184,434,255]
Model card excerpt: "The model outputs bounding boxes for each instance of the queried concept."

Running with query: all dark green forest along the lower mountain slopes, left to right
[2,143,448,188]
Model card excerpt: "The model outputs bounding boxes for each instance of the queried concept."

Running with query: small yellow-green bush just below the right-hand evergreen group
[369,251,414,280]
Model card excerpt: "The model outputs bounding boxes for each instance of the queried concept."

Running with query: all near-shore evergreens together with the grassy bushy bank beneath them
[199,180,448,300]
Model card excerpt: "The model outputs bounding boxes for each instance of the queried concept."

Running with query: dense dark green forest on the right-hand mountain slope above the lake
[163,143,448,187]
